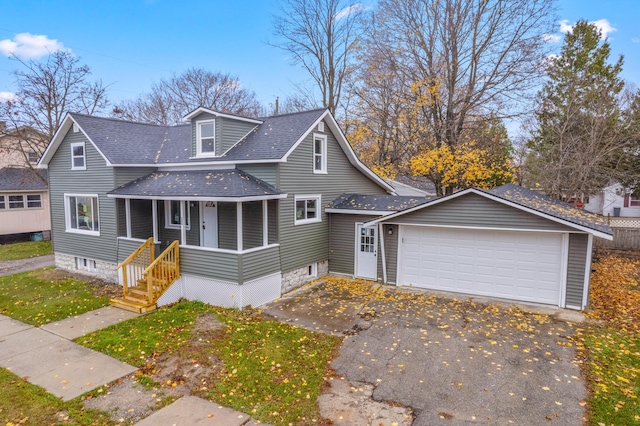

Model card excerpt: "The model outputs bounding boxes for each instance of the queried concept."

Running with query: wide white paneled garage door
[399,226,562,306]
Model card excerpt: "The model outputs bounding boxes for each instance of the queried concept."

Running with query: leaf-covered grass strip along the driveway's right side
[576,256,640,426]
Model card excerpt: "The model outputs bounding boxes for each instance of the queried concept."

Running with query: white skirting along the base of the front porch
[158,272,282,308]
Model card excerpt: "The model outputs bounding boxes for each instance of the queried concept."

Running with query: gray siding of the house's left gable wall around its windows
[49,130,118,263]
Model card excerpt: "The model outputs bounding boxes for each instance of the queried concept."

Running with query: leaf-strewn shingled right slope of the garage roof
[486,183,613,235]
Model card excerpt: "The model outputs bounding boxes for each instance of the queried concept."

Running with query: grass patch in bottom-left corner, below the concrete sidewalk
[0,368,115,426]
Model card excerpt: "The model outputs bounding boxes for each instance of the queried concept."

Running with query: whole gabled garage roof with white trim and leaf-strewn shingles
[367,183,613,240]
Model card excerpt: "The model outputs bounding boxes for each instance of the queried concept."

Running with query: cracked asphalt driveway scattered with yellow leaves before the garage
[264,278,587,425]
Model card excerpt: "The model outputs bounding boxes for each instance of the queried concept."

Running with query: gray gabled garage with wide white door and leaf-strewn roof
[353,184,612,309]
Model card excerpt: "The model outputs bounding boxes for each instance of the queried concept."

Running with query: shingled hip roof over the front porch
[108,169,286,201]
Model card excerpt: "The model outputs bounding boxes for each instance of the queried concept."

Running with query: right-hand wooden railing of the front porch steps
[138,241,180,303]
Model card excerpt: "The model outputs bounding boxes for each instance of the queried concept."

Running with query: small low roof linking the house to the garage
[325,194,427,215]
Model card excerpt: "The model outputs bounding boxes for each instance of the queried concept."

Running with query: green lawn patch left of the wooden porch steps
[0,269,109,325]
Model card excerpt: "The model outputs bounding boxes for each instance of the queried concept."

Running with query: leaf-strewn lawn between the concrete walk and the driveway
[77,302,341,425]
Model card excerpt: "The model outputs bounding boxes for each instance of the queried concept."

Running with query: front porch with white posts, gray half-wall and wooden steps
[109,168,286,310]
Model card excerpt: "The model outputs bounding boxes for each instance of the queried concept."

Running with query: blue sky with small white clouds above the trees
[0,0,640,110]
